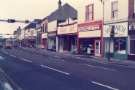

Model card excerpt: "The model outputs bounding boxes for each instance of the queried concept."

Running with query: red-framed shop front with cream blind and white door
[78,21,102,56]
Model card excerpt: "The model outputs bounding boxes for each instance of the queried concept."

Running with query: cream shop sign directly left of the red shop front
[57,24,77,35]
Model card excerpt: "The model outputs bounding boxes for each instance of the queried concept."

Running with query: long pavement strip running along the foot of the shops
[21,47,135,68]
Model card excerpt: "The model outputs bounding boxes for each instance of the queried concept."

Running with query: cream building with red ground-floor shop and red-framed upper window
[78,0,103,56]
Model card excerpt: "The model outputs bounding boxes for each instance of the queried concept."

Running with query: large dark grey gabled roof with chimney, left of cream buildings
[48,3,77,22]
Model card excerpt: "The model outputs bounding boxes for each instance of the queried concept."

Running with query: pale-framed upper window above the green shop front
[111,1,118,18]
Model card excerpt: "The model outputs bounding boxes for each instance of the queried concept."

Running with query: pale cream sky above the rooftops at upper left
[0,0,78,34]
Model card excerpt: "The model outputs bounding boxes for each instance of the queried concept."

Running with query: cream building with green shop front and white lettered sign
[103,0,129,59]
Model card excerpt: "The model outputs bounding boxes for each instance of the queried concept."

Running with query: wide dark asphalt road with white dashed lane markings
[0,49,135,90]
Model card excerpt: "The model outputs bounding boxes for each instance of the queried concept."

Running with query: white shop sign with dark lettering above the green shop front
[103,23,128,37]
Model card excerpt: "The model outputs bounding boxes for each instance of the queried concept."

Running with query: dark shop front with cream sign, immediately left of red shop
[57,23,77,52]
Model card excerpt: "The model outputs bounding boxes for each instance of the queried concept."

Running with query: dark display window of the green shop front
[114,38,126,54]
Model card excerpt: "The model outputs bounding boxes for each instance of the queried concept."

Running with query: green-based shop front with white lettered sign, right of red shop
[103,22,128,60]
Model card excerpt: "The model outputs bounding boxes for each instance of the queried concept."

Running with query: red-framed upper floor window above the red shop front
[85,4,94,21]
